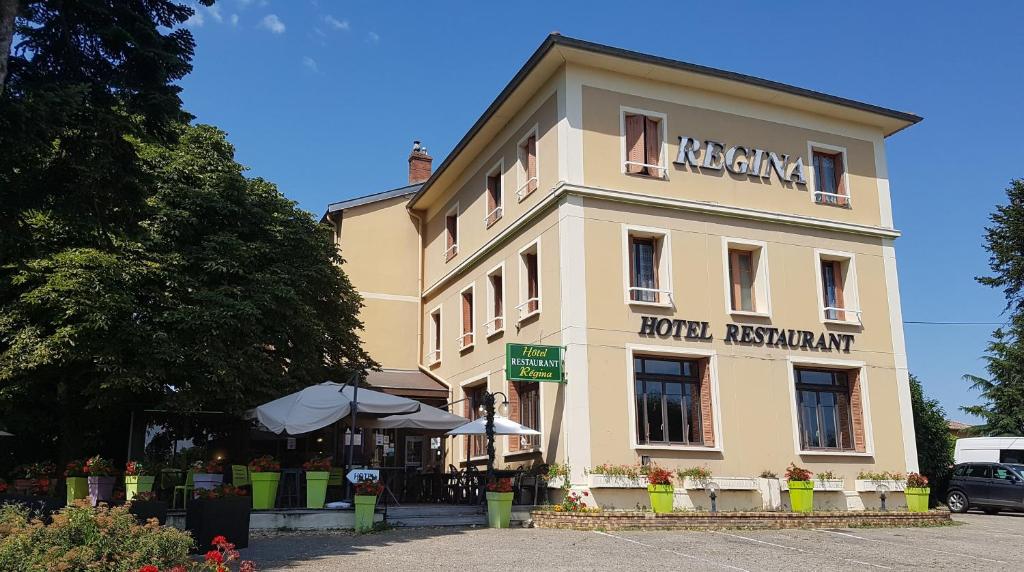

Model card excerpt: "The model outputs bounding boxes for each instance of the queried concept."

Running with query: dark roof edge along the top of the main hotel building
[409,34,924,208]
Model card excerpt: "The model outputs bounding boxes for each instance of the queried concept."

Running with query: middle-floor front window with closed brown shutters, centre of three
[724,238,771,315]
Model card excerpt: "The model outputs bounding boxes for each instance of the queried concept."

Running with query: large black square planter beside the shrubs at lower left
[185,484,252,551]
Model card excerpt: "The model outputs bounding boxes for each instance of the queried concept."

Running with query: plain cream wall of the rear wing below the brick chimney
[335,196,420,369]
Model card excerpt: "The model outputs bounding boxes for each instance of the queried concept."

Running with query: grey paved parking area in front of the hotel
[244,513,1024,572]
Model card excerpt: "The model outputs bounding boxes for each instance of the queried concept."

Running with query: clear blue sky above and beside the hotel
[182,0,1024,421]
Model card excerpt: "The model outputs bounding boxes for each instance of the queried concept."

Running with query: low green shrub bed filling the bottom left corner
[0,503,193,572]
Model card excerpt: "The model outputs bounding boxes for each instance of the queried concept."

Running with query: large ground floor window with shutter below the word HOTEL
[633,357,713,445]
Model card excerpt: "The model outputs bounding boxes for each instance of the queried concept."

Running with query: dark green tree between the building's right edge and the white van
[910,375,953,499]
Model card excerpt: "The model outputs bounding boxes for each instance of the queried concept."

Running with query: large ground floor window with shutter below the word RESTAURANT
[795,368,859,450]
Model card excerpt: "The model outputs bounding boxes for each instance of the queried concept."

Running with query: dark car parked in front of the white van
[946,463,1024,515]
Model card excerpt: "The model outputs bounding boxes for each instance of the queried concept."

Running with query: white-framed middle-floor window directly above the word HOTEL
[623,225,672,306]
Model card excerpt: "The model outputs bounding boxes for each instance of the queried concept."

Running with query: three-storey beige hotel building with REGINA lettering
[327,35,921,508]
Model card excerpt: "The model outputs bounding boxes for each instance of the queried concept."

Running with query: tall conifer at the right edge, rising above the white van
[962,179,1024,435]
